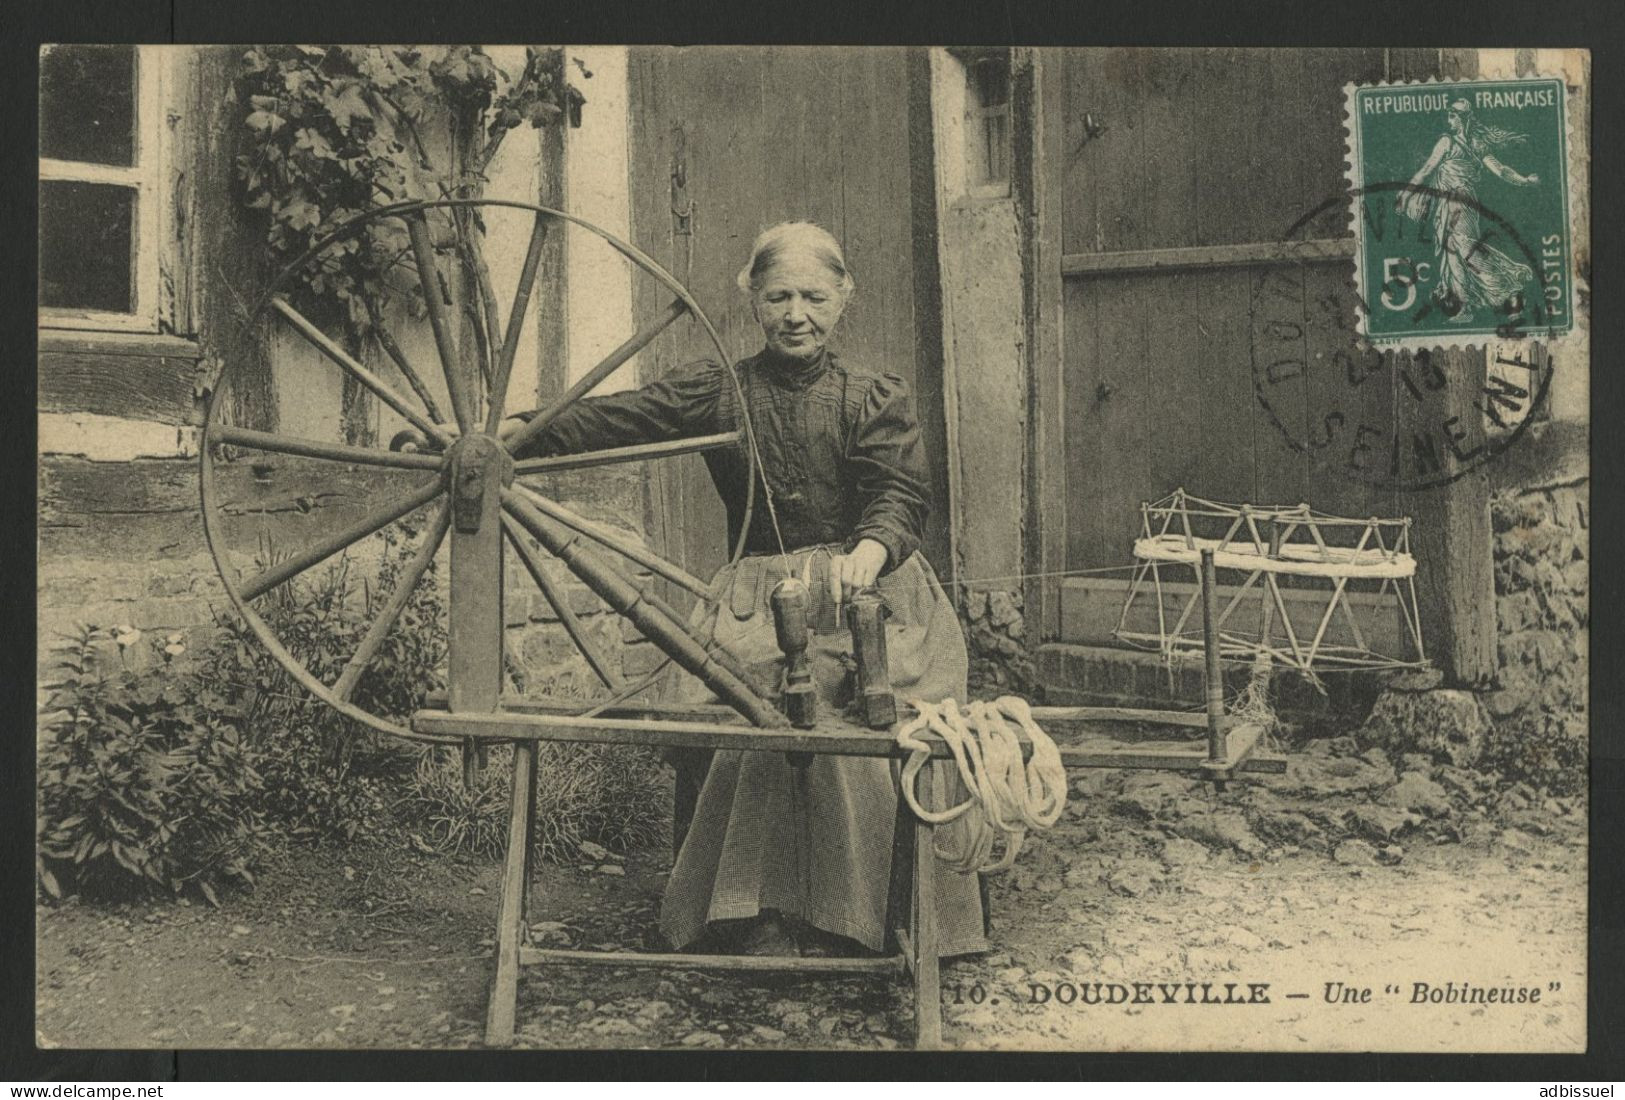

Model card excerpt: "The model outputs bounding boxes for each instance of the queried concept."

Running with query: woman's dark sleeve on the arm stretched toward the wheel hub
[515,361,726,458]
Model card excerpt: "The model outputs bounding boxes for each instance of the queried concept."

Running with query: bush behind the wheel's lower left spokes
[210,526,445,838]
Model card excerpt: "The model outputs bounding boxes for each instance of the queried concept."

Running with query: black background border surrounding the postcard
[0,0,1625,1084]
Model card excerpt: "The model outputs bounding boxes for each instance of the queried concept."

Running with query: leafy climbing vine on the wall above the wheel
[236,45,585,348]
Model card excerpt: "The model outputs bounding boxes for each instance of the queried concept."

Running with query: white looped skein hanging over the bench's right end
[897,695,1066,874]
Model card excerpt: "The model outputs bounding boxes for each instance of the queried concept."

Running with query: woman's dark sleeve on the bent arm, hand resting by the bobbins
[847,374,930,572]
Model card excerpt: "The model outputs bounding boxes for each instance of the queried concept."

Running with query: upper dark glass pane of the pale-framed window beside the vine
[39,45,135,166]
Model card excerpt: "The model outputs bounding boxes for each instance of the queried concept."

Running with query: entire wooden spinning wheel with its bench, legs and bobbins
[200,200,1285,1048]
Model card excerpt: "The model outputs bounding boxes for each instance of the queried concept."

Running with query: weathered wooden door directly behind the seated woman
[631,47,947,588]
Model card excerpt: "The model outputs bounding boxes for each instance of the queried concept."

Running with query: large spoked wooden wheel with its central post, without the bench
[200,198,782,743]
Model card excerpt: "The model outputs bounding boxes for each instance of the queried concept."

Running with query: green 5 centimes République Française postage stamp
[1346,76,1573,348]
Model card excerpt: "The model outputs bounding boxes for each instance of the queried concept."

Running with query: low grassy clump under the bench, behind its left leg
[401,743,671,863]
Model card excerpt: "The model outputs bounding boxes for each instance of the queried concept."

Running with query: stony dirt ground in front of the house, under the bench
[36,739,1586,1051]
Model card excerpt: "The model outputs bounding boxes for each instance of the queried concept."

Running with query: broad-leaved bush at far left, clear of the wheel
[36,627,263,902]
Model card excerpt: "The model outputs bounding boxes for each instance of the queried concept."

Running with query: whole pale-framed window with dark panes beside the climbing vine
[39,45,164,331]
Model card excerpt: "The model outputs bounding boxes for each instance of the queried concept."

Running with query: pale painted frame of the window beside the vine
[36,45,176,335]
